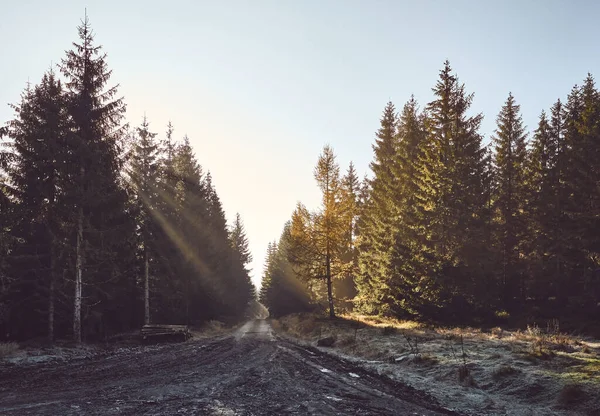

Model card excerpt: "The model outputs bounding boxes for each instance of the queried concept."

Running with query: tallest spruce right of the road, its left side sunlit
[417,61,486,316]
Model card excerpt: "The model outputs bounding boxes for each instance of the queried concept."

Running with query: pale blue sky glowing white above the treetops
[0,0,600,286]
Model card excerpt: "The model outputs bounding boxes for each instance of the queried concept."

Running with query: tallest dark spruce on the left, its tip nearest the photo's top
[60,16,129,342]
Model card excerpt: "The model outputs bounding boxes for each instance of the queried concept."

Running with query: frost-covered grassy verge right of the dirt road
[272,314,600,415]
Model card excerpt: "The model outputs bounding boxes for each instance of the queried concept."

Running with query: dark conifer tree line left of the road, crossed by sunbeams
[0,16,255,342]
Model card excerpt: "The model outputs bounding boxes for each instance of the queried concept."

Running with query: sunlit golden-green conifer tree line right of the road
[261,61,600,322]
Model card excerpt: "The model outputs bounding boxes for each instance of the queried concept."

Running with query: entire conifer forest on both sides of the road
[0,17,600,343]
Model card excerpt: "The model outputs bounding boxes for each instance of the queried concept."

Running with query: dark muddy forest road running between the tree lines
[0,319,455,416]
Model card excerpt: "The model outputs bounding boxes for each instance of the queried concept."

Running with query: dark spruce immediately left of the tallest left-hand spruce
[9,70,70,341]
